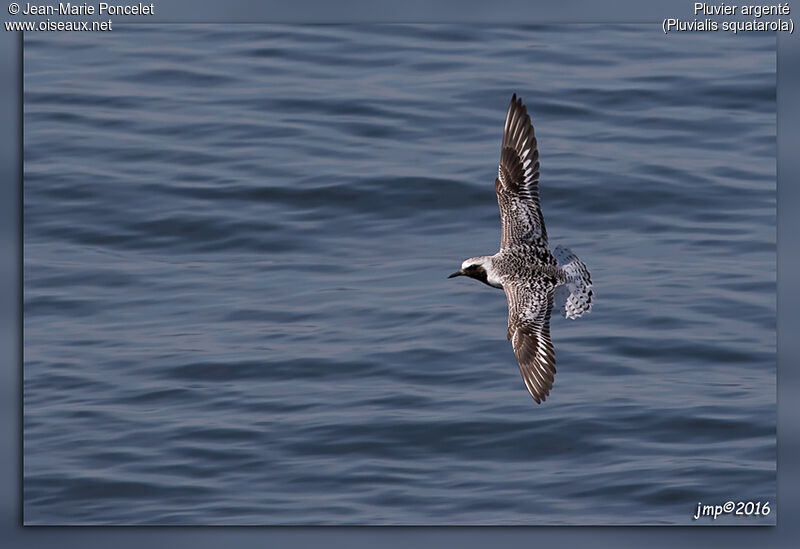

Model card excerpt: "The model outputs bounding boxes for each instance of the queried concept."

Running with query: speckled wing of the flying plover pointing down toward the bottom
[504,284,556,404]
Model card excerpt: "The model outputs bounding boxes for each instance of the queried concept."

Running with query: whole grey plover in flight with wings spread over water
[449,94,592,404]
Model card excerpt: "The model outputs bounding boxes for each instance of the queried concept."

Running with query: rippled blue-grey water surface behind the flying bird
[23,25,775,525]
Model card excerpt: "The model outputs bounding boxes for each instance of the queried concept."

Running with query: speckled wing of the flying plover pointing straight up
[494,94,547,248]
